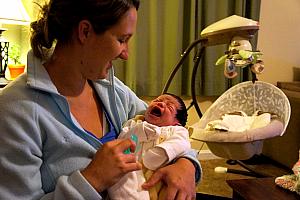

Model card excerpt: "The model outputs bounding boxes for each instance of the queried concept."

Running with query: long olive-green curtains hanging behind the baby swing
[114,0,260,96]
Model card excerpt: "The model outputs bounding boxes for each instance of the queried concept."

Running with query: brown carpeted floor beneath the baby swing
[197,154,290,199]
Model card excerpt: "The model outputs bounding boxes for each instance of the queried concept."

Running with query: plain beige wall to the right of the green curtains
[258,0,300,84]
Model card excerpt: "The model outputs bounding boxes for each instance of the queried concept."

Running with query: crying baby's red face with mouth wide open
[145,94,180,126]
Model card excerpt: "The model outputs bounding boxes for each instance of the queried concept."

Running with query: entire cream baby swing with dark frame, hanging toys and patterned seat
[162,15,291,176]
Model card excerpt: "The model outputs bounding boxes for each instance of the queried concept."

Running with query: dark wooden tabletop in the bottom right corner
[226,177,300,200]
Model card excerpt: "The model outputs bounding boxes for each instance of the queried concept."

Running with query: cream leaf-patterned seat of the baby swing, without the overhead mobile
[191,81,291,160]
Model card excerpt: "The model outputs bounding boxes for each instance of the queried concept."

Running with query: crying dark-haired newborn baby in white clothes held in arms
[108,93,191,200]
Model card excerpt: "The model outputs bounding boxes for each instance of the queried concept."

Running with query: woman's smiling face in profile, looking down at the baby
[84,8,137,80]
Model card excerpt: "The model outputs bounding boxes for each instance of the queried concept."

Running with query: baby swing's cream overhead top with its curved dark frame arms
[162,15,259,118]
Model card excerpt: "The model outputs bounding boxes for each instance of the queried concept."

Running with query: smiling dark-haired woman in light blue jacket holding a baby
[0,0,200,199]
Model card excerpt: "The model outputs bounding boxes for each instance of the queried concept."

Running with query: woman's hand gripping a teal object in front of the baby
[81,139,142,192]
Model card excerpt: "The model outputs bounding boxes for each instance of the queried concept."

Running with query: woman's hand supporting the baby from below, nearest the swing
[142,158,196,200]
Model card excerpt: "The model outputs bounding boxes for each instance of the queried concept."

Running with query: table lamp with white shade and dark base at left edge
[0,0,30,87]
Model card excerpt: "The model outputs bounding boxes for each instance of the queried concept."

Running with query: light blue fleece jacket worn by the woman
[0,51,201,200]
